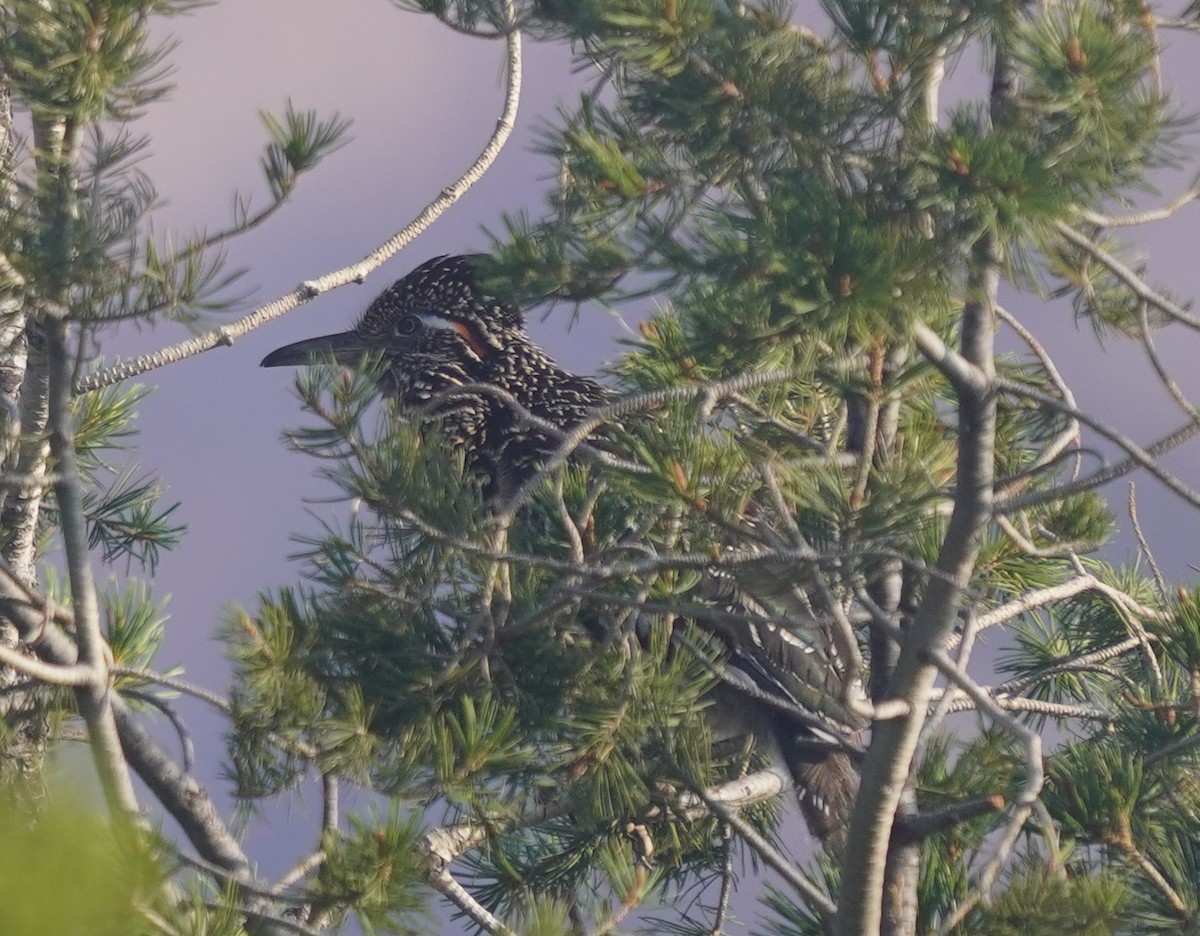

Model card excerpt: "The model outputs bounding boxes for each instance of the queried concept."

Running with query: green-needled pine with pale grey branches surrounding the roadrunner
[0,0,1200,936]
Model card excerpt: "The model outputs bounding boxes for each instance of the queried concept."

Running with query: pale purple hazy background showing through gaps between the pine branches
[96,0,1200,921]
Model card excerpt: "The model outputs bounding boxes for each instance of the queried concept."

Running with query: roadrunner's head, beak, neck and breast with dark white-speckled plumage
[263,257,611,499]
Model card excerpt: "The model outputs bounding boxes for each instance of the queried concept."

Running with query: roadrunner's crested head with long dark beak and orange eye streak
[262,256,524,406]
